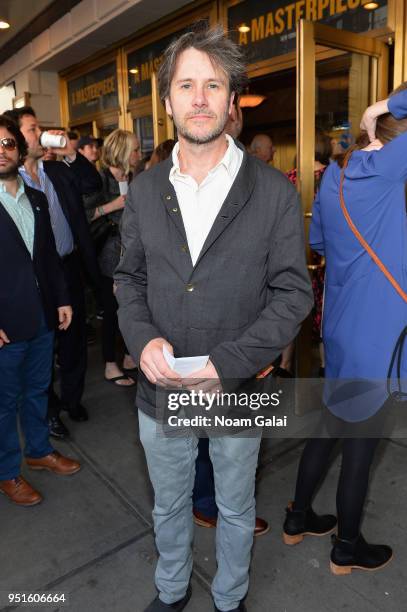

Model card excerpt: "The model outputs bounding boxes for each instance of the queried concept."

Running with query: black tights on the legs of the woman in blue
[294,438,379,540]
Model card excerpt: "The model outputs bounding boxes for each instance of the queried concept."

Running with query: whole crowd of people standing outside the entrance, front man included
[0,21,407,612]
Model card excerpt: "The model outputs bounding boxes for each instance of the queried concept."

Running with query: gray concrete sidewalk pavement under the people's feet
[0,346,407,612]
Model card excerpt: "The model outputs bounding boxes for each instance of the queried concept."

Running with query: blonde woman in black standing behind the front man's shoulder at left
[92,129,141,387]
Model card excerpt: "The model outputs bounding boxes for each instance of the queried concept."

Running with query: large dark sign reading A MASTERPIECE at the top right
[228,0,387,63]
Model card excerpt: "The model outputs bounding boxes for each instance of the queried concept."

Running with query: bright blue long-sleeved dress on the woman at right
[310,91,407,420]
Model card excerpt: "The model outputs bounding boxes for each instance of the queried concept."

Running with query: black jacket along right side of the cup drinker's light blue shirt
[44,161,100,287]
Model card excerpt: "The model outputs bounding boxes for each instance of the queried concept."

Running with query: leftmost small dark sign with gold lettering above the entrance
[68,62,119,121]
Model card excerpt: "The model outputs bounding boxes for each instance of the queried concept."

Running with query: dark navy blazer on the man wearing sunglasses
[0,185,70,342]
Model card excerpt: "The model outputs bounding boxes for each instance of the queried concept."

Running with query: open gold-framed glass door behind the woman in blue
[296,20,388,378]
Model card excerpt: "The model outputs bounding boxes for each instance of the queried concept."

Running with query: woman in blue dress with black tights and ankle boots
[283,82,407,574]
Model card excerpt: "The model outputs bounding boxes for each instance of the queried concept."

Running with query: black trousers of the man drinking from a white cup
[48,251,87,416]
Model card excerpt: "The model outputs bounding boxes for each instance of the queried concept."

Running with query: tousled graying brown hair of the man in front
[157,22,247,102]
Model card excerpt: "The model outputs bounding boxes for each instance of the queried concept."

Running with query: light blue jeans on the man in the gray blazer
[138,410,261,611]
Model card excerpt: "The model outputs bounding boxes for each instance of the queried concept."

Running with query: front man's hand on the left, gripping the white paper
[140,338,181,387]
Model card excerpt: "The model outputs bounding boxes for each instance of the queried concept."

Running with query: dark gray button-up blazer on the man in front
[115,143,313,416]
